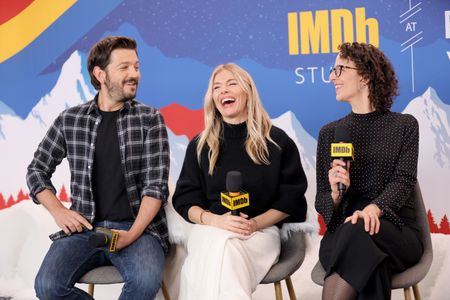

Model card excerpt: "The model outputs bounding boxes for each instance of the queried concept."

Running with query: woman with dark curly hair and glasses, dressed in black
[315,43,423,300]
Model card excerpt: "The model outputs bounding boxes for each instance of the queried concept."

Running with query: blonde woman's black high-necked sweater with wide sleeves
[173,123,307,222]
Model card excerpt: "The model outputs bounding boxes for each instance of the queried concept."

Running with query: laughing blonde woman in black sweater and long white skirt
[173,64,307,300]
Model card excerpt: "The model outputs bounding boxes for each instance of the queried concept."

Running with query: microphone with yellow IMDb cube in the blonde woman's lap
[220,171,250,216]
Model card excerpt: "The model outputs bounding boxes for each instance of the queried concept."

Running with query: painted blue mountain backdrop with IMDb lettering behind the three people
[0,0,450,300]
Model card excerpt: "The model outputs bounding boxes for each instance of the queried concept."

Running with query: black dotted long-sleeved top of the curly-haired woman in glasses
[315,112,419,231]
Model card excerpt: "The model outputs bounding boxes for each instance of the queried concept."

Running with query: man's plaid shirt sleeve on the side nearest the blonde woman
[141,111,170,205]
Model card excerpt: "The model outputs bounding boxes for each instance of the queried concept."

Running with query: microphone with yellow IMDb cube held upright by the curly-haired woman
[331,125,354,197]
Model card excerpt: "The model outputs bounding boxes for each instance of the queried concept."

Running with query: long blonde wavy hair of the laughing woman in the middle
[197,63,278,175]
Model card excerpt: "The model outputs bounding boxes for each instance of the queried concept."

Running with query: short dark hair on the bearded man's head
[87,36,137,91]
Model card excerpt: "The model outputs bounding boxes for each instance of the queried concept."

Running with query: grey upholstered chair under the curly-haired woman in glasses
[311,183,433,300]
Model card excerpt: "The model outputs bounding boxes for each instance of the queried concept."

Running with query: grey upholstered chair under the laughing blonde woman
[261,231,306,300]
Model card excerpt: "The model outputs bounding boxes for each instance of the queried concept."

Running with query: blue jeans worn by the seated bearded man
[35,221,164,300]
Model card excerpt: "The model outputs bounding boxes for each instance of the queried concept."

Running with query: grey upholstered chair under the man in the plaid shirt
[78,266,170,300]
